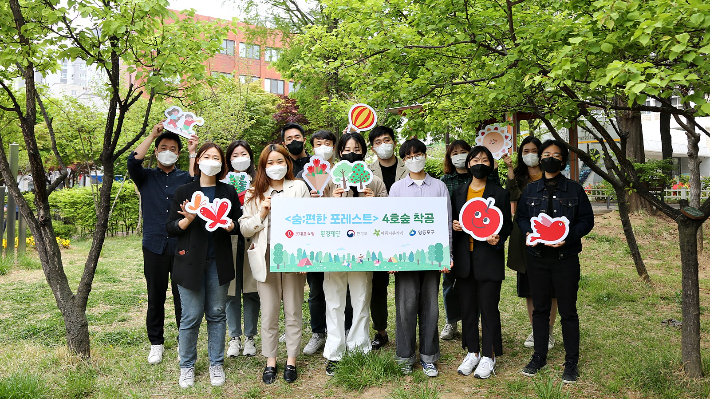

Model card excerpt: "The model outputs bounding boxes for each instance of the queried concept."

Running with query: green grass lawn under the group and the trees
[0,213,710,399]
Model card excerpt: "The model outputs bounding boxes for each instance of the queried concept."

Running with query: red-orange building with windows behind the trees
[185,13,294,95]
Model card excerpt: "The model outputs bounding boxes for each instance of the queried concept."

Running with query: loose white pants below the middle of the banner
[323,272,372,361]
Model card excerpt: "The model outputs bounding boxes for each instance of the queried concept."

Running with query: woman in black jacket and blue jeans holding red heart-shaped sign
[167,143,242,388]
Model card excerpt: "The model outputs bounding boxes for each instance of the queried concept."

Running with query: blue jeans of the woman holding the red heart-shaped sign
[178,259,229,368]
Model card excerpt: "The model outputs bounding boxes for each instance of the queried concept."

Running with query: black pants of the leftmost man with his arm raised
[143,246,182,345]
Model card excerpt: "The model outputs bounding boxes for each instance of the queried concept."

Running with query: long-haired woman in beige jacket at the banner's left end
[239,144,309,384]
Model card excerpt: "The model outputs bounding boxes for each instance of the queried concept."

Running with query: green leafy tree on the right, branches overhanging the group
[291,0,710,377]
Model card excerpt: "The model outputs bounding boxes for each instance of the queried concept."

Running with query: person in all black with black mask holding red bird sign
[516,140,594,383]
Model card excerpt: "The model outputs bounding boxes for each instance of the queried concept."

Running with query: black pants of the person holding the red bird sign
[527,252,580,363]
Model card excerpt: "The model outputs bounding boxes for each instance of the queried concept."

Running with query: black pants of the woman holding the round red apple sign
[456,270,503,358]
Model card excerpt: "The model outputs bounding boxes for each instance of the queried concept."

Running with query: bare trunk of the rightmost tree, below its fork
[678,222,703,378]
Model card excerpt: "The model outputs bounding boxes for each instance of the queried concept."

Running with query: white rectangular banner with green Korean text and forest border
[270,197,450,272]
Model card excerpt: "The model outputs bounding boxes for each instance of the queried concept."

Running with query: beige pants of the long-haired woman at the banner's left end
[257,266,306,357]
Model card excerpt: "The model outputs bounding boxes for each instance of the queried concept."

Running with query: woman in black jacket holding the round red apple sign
[451,146,513,378]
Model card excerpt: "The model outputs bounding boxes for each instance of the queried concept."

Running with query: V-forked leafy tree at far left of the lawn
[0,0,228,357]
